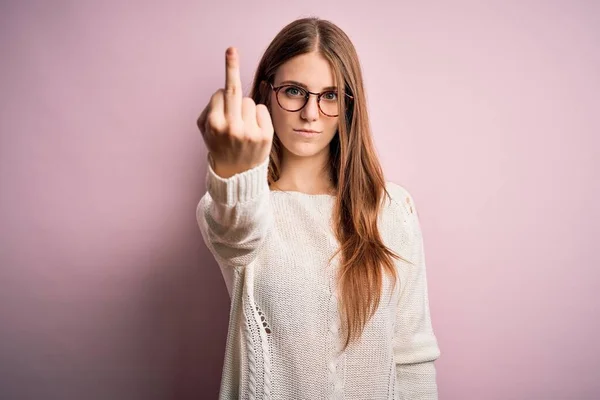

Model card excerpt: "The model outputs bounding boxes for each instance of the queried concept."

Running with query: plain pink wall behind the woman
[0,0,600,400]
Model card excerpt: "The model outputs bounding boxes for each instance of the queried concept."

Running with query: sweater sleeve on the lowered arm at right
[394,188,440,400]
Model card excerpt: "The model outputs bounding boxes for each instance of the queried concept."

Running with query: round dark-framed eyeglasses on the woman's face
[269,82,354,117]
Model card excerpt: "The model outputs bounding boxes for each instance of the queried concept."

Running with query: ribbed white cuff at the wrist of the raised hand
[206,157,269,206]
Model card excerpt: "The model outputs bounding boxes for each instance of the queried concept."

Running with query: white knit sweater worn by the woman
[196,158,440,400]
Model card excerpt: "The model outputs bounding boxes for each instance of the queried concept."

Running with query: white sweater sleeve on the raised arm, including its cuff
[196,157,272,268]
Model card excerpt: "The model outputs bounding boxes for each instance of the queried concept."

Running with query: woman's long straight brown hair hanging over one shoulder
[250,17,410,349]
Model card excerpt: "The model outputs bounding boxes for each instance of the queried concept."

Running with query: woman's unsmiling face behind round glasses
[270,52,338,157]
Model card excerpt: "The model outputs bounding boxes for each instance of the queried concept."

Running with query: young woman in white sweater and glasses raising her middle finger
[196,18,440,400]
